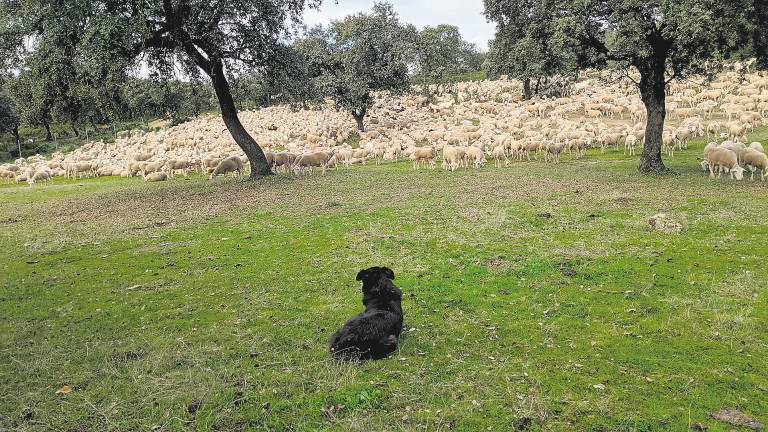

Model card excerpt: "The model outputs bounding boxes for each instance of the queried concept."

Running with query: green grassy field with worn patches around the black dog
[0,133,768,431]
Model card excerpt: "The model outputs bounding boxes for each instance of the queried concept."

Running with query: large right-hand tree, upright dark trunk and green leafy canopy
[484,0,768,173]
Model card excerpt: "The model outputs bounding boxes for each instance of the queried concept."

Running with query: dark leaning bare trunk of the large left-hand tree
[210,61,273,179]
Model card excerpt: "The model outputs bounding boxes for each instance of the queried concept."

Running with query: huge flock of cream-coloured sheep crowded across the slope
[0,66,768,185]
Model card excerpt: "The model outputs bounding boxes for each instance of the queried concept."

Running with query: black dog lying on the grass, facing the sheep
[331,267,403,360]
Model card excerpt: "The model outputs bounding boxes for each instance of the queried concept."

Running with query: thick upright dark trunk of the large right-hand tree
[638,58,669,174]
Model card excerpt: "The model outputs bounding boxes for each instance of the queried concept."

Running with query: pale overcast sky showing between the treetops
[304,0,496,50]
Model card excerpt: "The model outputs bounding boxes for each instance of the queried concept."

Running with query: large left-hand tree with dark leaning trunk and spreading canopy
[0,0,320,177]
